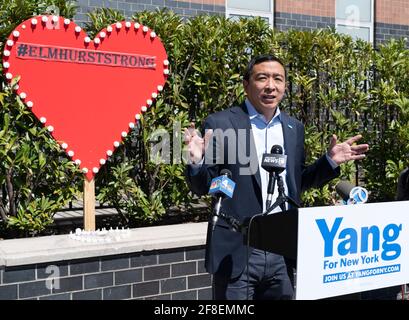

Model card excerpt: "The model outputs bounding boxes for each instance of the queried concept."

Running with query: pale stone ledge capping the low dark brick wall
[0,222,207,267]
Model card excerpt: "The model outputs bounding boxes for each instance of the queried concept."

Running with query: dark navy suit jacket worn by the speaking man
[186,103,339,278]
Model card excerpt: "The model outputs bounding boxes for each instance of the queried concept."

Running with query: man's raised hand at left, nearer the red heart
[184,122,213,163]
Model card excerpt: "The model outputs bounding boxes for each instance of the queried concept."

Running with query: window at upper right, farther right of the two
[335,0,375,43]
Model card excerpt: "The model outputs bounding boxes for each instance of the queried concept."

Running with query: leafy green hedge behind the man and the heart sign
[0,1,409,233]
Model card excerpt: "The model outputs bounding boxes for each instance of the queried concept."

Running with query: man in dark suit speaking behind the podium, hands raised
[184,55,368,300]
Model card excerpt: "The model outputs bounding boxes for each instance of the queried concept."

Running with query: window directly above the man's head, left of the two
[226,0,274,26]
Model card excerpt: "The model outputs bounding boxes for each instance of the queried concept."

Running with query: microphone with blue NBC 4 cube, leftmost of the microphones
[209,169,236,230]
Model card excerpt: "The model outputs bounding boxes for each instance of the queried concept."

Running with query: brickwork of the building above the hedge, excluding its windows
[75,0,409,46]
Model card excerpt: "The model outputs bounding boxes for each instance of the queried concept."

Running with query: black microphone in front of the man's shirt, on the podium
[261,144,287,210]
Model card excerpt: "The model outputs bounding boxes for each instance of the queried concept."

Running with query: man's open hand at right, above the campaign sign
[328,134,369,165]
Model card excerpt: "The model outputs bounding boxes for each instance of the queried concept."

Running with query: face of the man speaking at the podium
[243,61,286,118]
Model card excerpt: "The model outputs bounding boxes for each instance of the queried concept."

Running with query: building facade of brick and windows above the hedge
[75,0,409,47]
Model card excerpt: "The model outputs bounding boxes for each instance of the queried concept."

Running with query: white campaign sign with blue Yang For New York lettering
[296,201,409,299]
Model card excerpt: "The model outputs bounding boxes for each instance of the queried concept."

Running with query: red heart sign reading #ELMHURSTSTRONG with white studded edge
[3,16,169,180]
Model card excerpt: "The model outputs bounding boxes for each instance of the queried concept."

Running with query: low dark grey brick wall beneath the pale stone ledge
[0,246,211,300]
